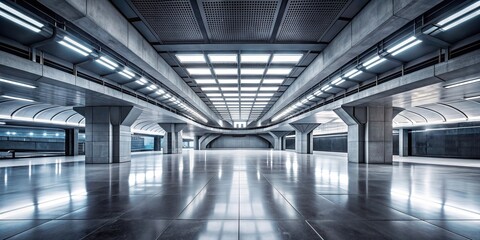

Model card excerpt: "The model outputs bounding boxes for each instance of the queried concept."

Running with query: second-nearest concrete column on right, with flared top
[290,123,320,154]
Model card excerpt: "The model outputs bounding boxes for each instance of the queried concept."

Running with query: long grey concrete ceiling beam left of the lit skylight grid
[40,0,220,124]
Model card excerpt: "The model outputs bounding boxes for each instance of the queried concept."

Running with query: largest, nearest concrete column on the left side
[74,106,142,163]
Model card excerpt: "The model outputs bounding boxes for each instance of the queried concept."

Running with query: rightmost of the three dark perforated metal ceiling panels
[277,0,349,41]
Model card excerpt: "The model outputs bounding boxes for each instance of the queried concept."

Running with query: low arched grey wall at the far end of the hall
[207,135,272,148]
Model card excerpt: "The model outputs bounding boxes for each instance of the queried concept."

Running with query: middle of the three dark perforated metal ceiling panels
[202,0,279,42]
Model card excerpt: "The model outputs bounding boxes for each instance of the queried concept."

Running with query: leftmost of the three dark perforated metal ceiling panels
[132,0,203,42]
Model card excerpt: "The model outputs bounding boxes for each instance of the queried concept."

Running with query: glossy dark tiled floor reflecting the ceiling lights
[0,150,480,240]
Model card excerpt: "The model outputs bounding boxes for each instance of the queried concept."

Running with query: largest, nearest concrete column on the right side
[334,106,394,164]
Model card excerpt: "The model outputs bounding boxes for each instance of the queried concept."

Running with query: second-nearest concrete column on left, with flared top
[158,123,187,154]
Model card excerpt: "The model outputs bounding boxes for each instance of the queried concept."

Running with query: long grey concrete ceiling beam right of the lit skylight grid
[261,0,441,122]
